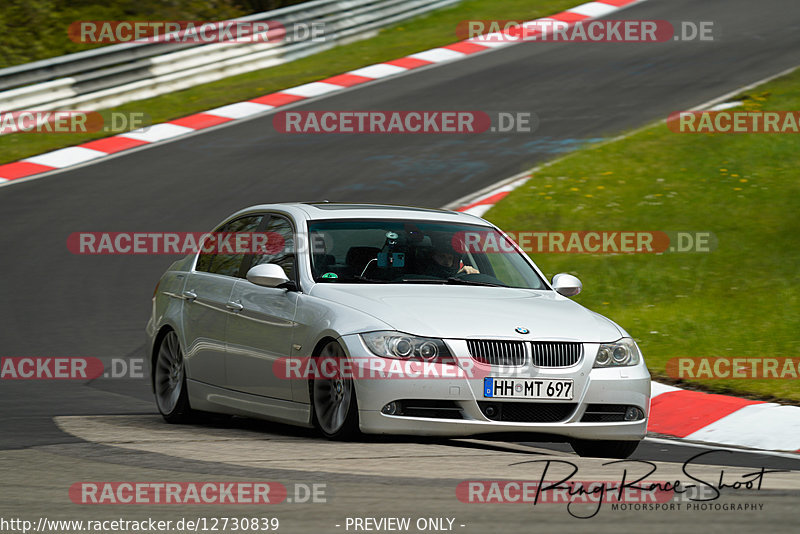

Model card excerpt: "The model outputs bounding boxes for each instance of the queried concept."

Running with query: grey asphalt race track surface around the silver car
[0,0,800,532]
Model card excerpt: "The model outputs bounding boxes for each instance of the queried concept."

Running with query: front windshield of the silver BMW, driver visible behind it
[308,219,547,289]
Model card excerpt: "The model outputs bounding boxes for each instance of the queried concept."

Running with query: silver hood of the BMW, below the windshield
[311,284,622,342]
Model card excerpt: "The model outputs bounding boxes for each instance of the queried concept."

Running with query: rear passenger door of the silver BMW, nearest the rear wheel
[181,215,263,386]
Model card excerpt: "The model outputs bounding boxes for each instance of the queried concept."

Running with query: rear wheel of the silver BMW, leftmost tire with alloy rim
[153,330,194,424]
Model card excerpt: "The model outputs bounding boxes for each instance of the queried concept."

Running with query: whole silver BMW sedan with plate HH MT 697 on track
[146,202,650,458]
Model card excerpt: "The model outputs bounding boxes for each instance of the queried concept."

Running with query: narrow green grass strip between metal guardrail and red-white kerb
[0,0,576,164]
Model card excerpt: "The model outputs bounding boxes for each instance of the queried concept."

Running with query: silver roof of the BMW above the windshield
[234,201,489,225]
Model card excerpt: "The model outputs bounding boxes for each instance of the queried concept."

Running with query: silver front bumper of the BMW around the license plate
[340,335,650,440]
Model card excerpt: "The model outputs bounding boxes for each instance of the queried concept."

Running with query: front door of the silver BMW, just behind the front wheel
[226,215,298,400]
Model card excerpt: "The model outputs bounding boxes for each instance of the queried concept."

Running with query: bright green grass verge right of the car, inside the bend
[486,70,800,404]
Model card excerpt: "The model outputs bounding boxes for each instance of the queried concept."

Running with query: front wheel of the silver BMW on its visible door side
[309,341,361,440]
